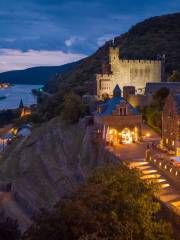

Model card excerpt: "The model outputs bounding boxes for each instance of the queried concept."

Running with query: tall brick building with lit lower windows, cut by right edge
[162,93,180,156]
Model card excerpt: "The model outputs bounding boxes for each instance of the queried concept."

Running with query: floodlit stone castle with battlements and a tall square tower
[96,47,163,98]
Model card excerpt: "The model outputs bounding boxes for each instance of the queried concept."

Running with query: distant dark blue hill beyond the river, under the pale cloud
[0,63,77,84]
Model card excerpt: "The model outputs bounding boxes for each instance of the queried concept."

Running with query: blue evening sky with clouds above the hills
[0,0,180,72]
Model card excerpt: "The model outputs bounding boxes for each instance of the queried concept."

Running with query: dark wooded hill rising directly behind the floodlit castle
[46,13,180,93]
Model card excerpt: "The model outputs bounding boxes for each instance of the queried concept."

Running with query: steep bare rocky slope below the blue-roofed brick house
[0,118,107,229]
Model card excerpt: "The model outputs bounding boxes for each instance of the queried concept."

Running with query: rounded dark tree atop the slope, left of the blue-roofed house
[61,92,86,123]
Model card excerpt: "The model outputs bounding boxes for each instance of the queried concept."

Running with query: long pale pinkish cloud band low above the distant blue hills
[0,49,86,72]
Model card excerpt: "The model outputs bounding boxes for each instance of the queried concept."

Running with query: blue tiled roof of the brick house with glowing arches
[98,96,140,116]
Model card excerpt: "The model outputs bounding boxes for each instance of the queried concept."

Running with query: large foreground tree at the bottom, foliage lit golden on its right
[24,165,171,240]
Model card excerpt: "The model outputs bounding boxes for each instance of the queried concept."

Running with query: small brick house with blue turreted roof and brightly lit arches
[94,85,142,144]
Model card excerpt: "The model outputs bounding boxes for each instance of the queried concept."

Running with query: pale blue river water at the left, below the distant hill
[0,85,42,110]
